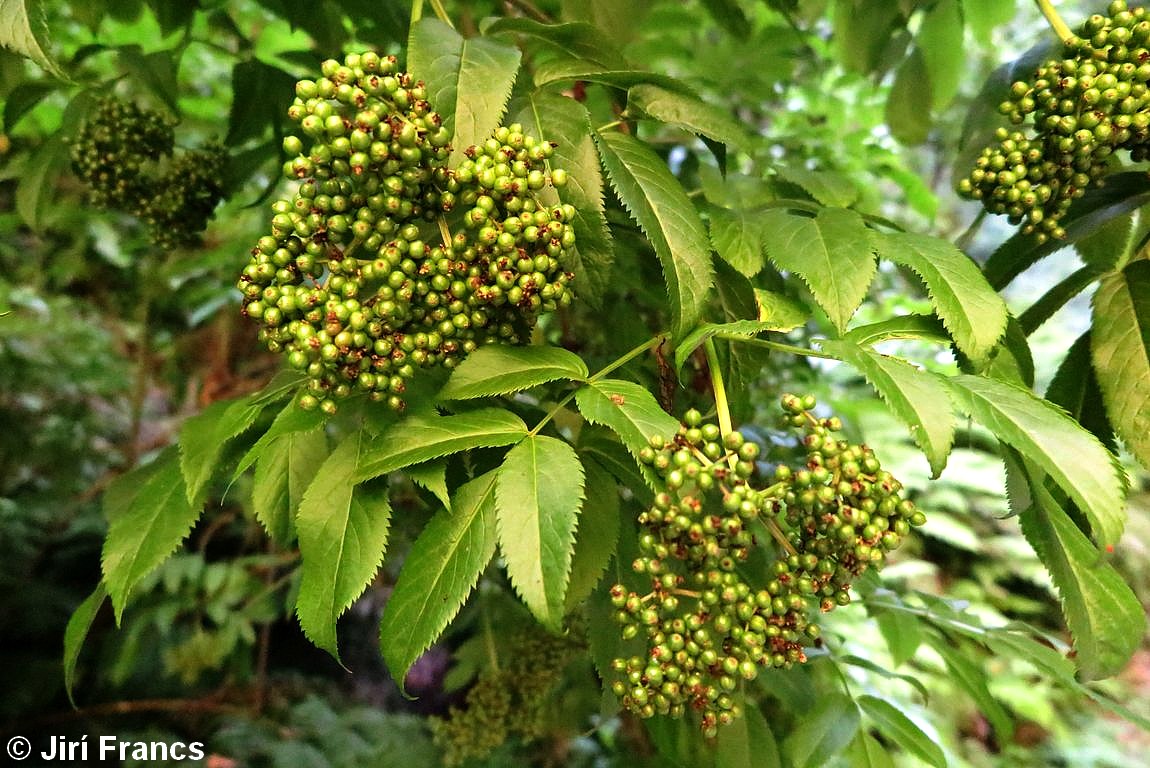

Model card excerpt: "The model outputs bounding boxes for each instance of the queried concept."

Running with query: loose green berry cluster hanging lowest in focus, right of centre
[611,395,926,735]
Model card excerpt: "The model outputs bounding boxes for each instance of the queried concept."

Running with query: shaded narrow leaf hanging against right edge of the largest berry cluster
[515,91,615,307]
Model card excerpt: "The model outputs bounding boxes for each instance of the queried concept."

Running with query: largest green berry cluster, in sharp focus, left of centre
[238,52,575,413]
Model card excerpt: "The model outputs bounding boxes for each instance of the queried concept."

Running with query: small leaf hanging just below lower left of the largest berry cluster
[252,429,328,546]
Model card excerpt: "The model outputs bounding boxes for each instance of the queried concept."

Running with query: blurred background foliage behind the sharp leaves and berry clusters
[0,0,1150,768]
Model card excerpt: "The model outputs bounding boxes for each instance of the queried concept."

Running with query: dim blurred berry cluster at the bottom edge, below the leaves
[430,630,578,768]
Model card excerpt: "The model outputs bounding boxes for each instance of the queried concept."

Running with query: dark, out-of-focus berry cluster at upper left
[71,98,228,248]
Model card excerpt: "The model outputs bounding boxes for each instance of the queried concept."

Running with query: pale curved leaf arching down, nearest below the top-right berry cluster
[874,232,1006,364]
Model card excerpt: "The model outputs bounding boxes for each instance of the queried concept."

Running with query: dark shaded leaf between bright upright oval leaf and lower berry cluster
[567,459,621,610]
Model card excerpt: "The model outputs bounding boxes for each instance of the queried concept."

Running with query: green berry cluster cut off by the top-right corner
[958,0,1150,241]
